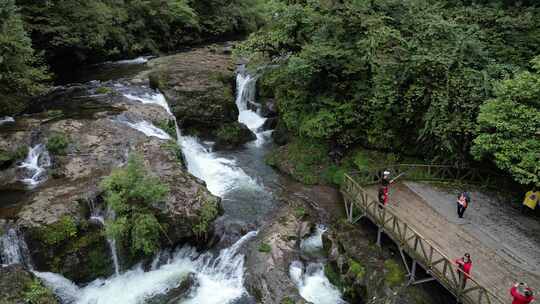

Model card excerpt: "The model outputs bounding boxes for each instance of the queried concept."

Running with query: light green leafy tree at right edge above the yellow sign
[472,57,540,187]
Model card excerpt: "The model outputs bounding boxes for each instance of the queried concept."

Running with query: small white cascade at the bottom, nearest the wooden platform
[289,261,347,304]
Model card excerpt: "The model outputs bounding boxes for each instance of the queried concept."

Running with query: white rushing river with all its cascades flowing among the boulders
[0,56,340,304]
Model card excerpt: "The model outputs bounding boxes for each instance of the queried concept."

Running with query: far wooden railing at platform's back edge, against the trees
[350,164,515,189]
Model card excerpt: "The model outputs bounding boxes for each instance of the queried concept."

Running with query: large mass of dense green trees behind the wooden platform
[238,0,540,186]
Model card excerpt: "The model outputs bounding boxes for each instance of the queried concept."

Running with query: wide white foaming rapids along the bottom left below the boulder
[35,231,257,304]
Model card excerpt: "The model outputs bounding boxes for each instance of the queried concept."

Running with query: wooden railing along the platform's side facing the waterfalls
[341,174,505,304]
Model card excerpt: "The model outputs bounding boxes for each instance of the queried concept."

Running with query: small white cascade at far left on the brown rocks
[19,144,51,187]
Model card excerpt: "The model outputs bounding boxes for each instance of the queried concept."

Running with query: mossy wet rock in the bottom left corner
[0,265,59,304]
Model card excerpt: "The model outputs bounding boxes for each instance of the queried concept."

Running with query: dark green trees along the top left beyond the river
[0,0,264,116]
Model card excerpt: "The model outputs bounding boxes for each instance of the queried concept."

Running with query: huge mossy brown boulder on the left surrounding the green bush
[4,85,221,283]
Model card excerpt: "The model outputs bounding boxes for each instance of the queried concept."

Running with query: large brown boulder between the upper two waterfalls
[143,47,238,130]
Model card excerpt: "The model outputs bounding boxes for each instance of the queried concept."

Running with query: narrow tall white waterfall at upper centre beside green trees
[236,71,266,146]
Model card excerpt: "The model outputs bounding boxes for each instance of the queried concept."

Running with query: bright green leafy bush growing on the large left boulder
[101,155,169,255]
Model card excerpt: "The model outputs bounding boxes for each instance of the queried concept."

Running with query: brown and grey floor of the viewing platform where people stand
[369,183,540,299]
